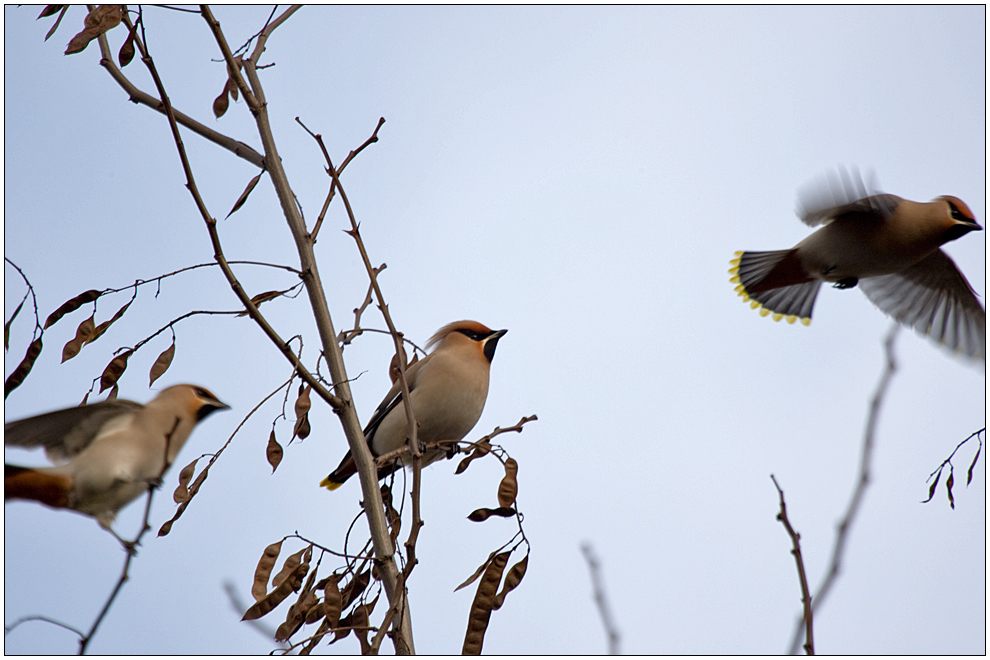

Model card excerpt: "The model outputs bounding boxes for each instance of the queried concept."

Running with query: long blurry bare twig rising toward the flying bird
[788,323,900,655]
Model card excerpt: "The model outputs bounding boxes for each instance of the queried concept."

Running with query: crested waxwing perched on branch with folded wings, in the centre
[320,321,508,490]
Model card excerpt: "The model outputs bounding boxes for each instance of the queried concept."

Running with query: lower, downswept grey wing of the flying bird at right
[859,250,987,359]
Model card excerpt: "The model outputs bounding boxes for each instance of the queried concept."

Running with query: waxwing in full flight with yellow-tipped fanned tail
[729,170,986,359]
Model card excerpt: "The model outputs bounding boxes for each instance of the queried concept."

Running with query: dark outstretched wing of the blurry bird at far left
[3,399,144,463]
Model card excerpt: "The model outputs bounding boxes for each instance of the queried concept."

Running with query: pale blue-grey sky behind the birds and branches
[4,6,987,654]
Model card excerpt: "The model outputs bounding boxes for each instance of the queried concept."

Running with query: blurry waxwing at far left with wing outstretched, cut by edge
[3,385,230,531]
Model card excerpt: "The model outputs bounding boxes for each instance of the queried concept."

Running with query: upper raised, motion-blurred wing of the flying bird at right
[797,168,900,227]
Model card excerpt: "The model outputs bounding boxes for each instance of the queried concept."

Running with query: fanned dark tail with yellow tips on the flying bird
[729,249,822,325]
